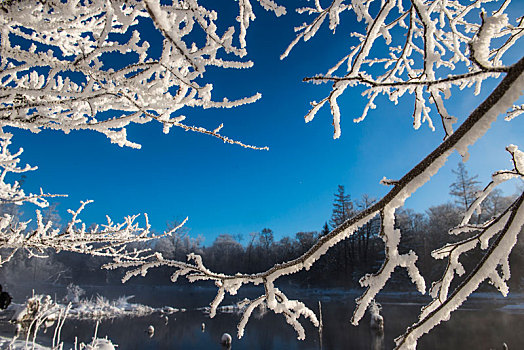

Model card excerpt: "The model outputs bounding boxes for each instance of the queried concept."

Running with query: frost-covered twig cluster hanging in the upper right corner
[281,0,524,138]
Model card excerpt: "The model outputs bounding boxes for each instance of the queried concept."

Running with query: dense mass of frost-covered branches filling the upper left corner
[0,0,285,149]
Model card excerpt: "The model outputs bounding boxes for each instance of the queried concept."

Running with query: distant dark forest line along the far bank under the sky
[0,163,524,291]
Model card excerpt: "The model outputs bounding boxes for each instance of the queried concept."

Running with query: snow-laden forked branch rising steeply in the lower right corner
[395,145,524,349]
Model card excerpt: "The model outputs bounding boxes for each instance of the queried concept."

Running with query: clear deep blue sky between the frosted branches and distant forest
[10,4,524,245]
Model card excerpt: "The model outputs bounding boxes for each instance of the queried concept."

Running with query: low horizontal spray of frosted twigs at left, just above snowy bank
[0,201,187,266]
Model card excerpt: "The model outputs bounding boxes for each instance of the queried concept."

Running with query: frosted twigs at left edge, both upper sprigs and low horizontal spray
[0,129,186,266]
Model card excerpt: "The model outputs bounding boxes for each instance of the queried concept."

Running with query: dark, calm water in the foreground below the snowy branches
[1,290,524,350]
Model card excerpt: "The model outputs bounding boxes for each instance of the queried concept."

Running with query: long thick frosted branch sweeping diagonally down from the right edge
[105,58,524,339]
